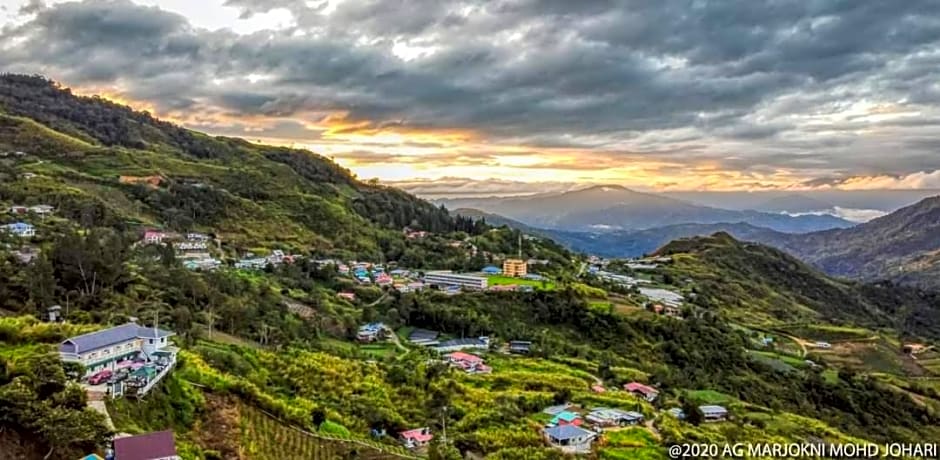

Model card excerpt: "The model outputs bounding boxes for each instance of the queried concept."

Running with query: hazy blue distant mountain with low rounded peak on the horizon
[438,185,853,233]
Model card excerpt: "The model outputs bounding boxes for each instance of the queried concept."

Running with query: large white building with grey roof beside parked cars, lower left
[59,322,177,376]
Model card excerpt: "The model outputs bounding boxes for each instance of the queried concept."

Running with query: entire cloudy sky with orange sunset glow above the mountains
[0,0,940,193]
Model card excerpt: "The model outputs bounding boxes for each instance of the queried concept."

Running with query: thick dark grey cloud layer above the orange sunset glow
[0,0,940,179]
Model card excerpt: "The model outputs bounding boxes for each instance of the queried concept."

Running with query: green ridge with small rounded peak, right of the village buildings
[657,233,940,339]
